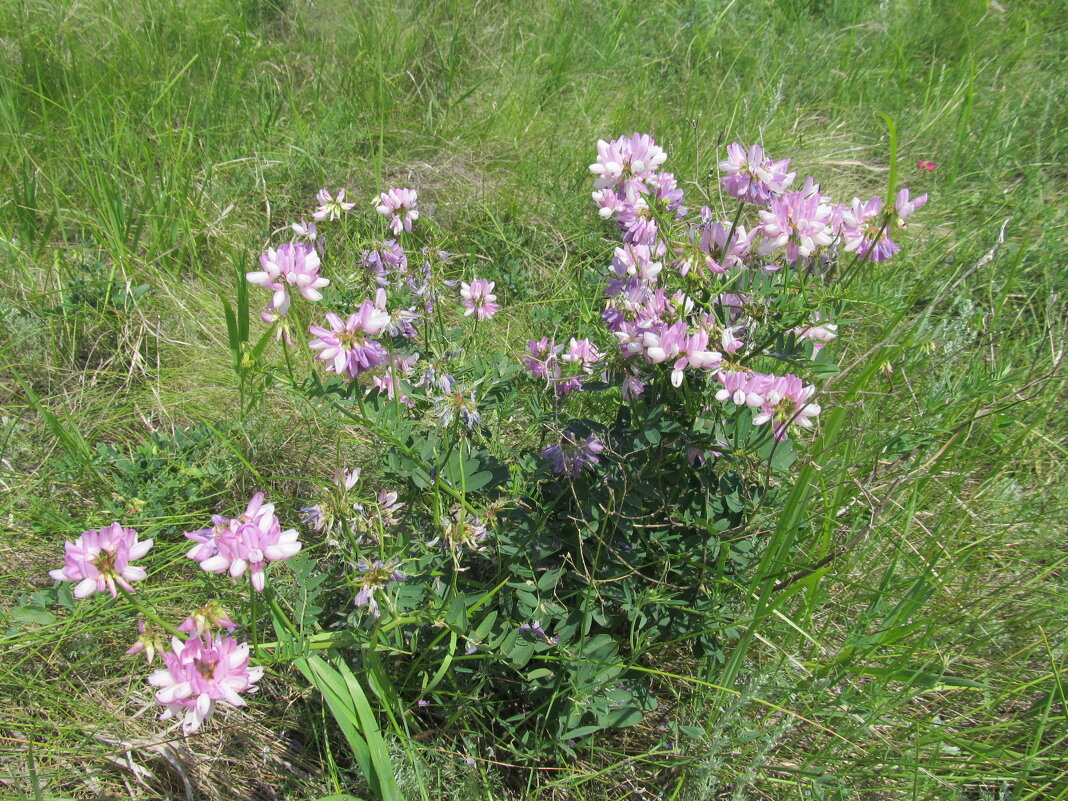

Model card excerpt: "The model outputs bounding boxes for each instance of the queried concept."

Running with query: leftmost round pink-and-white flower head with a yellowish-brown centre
[48,522,153,598]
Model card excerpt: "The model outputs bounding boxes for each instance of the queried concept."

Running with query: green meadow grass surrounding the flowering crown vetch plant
[0,0,1068,801]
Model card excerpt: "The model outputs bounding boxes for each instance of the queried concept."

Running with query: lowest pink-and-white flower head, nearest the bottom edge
[148,633,264,734]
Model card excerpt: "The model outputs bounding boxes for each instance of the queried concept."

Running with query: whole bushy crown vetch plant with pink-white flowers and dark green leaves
[41,134,927,777]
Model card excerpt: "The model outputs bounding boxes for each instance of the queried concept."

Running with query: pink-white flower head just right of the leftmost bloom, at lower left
[186,492,301,593]
